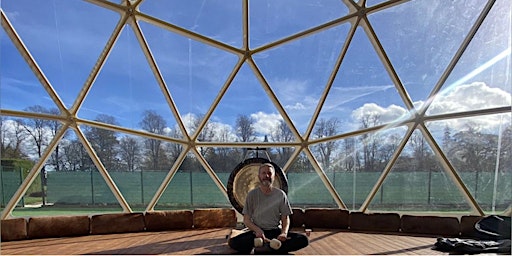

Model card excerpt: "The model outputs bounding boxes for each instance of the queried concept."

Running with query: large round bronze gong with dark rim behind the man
[227,157,288,214]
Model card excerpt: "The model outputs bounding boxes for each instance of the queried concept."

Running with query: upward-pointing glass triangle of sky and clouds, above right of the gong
[314,28,409,136]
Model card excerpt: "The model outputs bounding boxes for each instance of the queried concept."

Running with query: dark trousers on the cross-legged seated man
[228,229,309,254]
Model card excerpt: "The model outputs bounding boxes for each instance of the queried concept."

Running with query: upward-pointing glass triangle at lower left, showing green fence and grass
[9,127,122,216]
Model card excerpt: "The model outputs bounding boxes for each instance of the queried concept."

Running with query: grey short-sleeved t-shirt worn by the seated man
[242,187,292,230]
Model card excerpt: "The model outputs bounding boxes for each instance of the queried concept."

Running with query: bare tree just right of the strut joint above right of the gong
[313,117,340,170]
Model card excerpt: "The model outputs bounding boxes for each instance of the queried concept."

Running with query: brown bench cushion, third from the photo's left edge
[91,213,145,234]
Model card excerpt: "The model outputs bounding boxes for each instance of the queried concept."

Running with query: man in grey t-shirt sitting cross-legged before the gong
[228,163,309,254]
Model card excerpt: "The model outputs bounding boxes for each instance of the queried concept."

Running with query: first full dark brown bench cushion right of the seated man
[304,208,349,229]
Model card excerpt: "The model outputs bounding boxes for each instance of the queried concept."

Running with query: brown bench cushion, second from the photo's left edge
[27,216,89,238]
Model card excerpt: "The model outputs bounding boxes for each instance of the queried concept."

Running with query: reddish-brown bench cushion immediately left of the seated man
[193,209,236,228]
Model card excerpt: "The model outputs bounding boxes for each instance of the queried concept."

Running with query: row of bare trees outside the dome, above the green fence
[0,105,512,177]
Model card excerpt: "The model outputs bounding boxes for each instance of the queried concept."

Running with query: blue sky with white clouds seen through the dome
[0,0,511,142]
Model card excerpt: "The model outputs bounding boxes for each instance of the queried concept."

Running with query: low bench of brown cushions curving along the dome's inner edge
[1,208,476,241]
